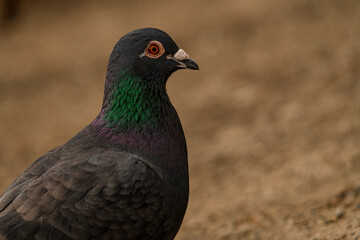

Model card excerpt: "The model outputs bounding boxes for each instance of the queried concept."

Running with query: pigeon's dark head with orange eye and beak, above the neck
[108,28,199,82]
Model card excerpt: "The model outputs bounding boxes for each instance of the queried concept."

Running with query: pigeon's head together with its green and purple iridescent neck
[91,28,199,146]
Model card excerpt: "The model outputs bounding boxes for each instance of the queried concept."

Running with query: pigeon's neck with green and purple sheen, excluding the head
[90,72,186,156]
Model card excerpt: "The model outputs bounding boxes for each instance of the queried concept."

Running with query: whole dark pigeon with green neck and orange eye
[0,28,199,240]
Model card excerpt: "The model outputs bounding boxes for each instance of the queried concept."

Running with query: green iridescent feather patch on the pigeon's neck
[104,72,171,128]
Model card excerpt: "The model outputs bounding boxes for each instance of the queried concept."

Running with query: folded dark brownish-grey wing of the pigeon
[0,149,166,240]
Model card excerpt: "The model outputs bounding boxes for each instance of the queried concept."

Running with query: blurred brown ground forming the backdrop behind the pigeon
[0,0,360,240]
